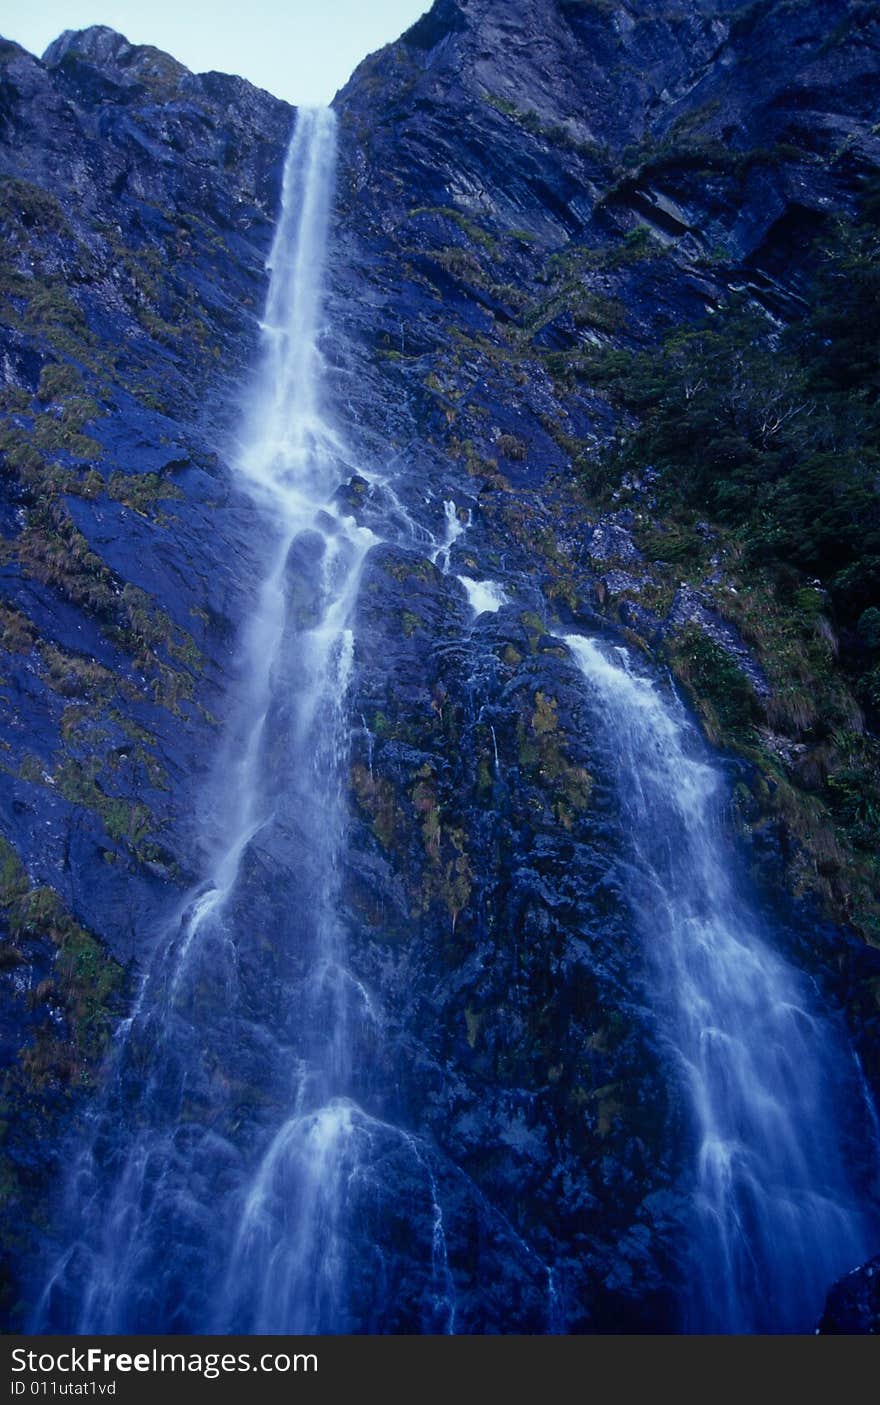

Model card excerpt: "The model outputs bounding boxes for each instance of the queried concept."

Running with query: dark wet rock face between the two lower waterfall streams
[338,538,675,1332]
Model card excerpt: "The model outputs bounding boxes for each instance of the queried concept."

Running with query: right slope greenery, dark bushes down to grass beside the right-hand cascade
[582,185,880,941]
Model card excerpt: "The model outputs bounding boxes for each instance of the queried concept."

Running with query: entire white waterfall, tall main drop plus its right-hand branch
[34,111,870,1332]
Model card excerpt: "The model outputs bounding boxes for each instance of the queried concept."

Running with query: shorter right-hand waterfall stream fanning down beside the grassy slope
[564,635,869,1332]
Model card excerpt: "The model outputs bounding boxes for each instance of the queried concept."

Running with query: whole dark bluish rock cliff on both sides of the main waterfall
[0,0,880,1332]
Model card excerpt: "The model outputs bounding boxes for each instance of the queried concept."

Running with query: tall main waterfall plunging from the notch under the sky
[34,110,375,1332]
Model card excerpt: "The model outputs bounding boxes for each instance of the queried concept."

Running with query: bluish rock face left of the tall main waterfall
[0,28,292,1322]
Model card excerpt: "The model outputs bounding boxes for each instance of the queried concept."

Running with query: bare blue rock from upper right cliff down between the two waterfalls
[319,0,877,1331]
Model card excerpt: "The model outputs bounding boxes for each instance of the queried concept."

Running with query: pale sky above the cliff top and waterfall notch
[0,0,430,105]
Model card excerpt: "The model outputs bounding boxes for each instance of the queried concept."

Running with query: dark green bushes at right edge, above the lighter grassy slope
[598,195,880,685]
